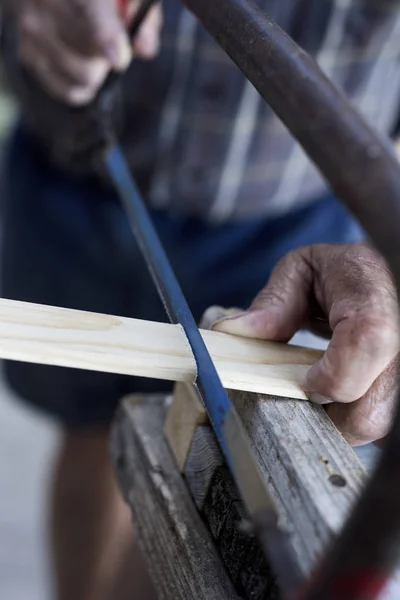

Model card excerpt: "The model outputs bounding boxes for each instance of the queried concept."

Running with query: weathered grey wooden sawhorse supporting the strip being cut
[112,384,366,600]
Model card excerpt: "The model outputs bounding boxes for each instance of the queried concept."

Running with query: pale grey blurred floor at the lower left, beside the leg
[0,378,58,600]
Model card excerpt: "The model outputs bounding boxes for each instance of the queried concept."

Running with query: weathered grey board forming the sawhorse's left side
[111,397,239,600]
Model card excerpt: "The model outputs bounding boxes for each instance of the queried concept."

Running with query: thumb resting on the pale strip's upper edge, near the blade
[213,248,313,342]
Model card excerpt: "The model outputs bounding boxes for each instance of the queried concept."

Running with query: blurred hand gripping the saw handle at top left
[14,0,162,105]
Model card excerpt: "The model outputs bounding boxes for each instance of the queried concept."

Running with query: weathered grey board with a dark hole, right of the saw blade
[230,392,366,572]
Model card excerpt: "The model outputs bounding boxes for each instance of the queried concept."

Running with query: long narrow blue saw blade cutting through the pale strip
[104,141,302,594]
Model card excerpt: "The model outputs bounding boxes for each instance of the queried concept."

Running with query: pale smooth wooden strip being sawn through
[0,299,321,399]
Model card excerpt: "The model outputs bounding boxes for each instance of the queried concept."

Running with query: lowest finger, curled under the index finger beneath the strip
[325,358,399,446]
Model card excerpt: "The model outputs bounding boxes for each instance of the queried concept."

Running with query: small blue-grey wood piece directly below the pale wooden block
[184,425,224,510]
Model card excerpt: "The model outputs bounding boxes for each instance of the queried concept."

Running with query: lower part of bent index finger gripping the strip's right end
[304,307,399,404]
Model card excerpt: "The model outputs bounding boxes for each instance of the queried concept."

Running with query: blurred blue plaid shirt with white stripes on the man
[3,0,400,222]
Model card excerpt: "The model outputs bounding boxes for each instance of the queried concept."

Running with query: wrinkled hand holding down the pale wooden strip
[215,245,399,445]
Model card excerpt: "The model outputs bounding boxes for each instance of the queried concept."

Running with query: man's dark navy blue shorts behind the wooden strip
[2,130,361,427]
